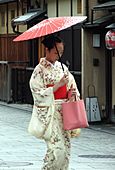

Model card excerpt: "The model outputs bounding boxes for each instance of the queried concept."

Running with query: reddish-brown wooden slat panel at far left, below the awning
[0,35,28,62]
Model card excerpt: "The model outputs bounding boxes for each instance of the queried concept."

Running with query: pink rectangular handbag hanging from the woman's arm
[62,100,89,130]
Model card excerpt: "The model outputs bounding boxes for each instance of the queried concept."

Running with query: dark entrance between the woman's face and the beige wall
[60,27,81,93]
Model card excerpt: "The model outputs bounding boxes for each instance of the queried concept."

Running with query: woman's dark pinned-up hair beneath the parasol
[42,35,63,51]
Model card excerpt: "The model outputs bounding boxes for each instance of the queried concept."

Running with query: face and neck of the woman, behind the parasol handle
[46,43,64,64]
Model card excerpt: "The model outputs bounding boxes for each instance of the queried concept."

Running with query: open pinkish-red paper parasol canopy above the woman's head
[13,16,87,41]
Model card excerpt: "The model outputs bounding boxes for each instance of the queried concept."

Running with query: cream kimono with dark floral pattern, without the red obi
[30,58,80,170]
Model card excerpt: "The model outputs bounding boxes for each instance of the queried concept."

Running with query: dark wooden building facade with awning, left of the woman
[0,0,47,103]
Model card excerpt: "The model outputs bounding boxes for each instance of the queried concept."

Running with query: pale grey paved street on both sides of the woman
[0,102,115,170]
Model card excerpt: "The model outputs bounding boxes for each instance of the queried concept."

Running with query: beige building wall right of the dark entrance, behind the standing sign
[82,0,108,117]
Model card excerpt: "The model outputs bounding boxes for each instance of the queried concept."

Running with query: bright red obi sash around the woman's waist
[47,84,67,99]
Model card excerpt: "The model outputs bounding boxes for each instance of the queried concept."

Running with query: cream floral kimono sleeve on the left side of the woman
[30,65,54,107]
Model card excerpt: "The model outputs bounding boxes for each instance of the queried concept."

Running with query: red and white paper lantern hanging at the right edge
[105,30,115,50]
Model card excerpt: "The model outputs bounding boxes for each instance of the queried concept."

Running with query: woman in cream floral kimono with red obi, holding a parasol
[30,36,80,170]
